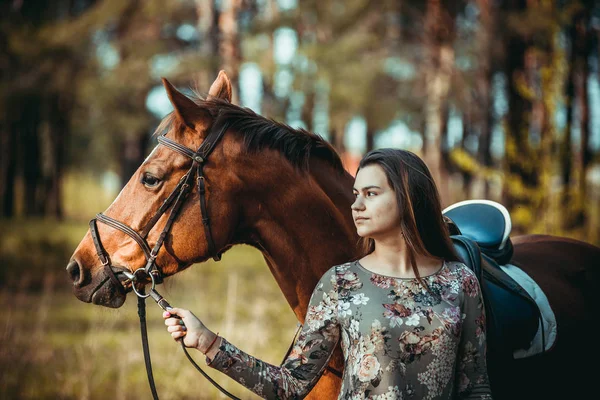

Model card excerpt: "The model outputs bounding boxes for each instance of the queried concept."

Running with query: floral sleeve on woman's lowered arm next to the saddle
[456,268,492,400]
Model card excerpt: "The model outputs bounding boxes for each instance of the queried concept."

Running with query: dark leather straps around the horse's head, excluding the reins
[90,129,225,294]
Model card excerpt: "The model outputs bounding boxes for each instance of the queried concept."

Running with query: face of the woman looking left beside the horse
[352,164,400,240]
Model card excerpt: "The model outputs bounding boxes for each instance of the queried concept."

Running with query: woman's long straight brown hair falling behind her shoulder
[357,149,459,284]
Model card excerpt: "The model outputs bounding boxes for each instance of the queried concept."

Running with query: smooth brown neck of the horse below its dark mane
[240,158,358,321]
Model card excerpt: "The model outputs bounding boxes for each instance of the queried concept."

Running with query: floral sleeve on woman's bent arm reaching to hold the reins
[209,267,340,399]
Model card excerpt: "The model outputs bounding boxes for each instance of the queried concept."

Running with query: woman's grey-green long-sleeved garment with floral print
[207,261,492,400]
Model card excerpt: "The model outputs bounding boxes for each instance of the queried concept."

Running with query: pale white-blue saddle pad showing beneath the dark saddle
[500,264,556,358]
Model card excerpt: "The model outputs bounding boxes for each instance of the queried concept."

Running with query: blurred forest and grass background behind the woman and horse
[0,0,600,399]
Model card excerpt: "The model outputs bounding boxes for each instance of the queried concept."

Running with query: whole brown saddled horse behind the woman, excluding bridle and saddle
[67,72,600,399]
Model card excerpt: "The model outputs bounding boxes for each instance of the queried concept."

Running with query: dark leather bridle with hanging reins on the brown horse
[90,123,239,400]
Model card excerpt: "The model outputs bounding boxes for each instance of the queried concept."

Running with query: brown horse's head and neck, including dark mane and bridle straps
[67,71,357,310]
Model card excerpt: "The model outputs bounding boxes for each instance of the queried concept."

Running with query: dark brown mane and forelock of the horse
[156,92,345,173]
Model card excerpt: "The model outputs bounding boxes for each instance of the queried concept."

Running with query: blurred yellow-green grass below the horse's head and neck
[0,220,296,400]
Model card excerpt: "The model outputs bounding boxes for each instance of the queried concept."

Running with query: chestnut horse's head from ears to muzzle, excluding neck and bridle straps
[67,72,251,308]
